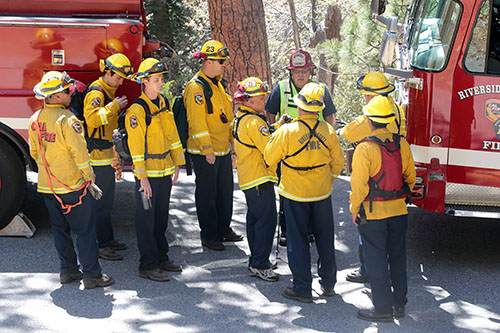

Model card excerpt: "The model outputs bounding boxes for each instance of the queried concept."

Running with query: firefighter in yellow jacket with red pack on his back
[350,96,416,322]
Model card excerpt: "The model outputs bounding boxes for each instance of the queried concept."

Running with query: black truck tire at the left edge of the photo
[0,139,26,230]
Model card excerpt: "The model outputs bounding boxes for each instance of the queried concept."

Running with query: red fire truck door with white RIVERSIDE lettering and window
[446,0,500,205]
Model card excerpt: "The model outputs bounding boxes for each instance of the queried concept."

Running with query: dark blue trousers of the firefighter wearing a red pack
[358,215,408,313]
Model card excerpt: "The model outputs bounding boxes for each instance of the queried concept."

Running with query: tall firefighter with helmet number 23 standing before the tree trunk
[184,40,243,251]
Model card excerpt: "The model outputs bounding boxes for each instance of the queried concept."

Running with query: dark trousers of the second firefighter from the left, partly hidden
[92,165,115,248]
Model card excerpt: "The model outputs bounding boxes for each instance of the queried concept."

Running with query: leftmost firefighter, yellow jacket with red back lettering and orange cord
[29,71,114,289]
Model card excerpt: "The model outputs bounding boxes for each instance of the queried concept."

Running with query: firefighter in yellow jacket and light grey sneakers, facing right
[233,77,285,281]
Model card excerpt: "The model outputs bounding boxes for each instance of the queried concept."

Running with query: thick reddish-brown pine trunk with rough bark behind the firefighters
[208,0,271,92]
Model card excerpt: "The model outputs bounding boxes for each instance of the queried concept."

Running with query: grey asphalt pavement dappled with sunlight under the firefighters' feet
[0,173,500,332]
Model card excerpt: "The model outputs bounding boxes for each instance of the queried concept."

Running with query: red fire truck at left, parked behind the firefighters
[0,0,159,229]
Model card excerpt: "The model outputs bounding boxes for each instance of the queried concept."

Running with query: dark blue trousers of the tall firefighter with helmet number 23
[191,154,234,240]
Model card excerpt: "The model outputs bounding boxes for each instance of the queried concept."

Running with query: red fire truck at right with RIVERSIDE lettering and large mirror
[372,0,500,218]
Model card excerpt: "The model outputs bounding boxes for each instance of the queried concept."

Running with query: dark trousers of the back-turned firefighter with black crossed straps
[283,197,337,297]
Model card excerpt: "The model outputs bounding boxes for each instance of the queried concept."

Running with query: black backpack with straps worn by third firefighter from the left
[113,94,170,162]
